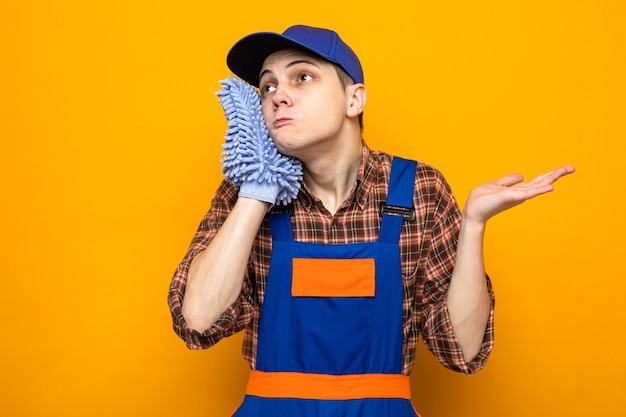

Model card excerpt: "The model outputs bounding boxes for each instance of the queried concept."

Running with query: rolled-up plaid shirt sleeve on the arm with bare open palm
[416,167,494,375]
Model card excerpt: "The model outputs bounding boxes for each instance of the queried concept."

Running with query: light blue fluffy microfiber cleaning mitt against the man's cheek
[216,76,302,205]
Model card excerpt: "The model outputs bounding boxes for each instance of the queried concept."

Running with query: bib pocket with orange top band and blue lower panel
[290,258,376,375]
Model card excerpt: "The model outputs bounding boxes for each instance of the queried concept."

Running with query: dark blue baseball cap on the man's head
[226,25,363,87]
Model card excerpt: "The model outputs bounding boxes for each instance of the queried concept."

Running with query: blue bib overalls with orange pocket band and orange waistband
[233,158,417,417]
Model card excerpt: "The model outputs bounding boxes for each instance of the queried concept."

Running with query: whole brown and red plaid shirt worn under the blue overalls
[169,142,494,375]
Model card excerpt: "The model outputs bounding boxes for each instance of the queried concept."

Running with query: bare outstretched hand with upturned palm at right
[464,166,574,223]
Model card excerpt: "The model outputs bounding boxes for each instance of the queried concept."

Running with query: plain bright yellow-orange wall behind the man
[0,0,626,417]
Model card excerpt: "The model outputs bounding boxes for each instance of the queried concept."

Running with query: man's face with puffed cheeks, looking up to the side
[259,50,349,159]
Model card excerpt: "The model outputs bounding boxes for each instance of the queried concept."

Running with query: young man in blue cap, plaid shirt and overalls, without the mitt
[169,26,573,417]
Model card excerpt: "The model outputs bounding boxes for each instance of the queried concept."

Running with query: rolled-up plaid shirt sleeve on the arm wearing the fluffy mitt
[168,182,253,349]
